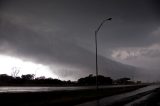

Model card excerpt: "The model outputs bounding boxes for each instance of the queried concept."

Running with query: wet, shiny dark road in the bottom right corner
[76,85,160,106]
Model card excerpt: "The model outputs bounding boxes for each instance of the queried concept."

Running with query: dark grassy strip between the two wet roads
[0,85,148,106]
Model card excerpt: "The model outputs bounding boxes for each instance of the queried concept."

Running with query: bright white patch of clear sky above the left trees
[0,55,58,78]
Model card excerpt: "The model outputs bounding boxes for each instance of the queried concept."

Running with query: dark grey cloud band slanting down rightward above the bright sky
[0,17,135,78]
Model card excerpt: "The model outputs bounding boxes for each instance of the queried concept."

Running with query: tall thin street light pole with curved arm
[95,18,112,90]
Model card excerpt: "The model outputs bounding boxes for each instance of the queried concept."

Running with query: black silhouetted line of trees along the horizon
[0,74,141,86]
